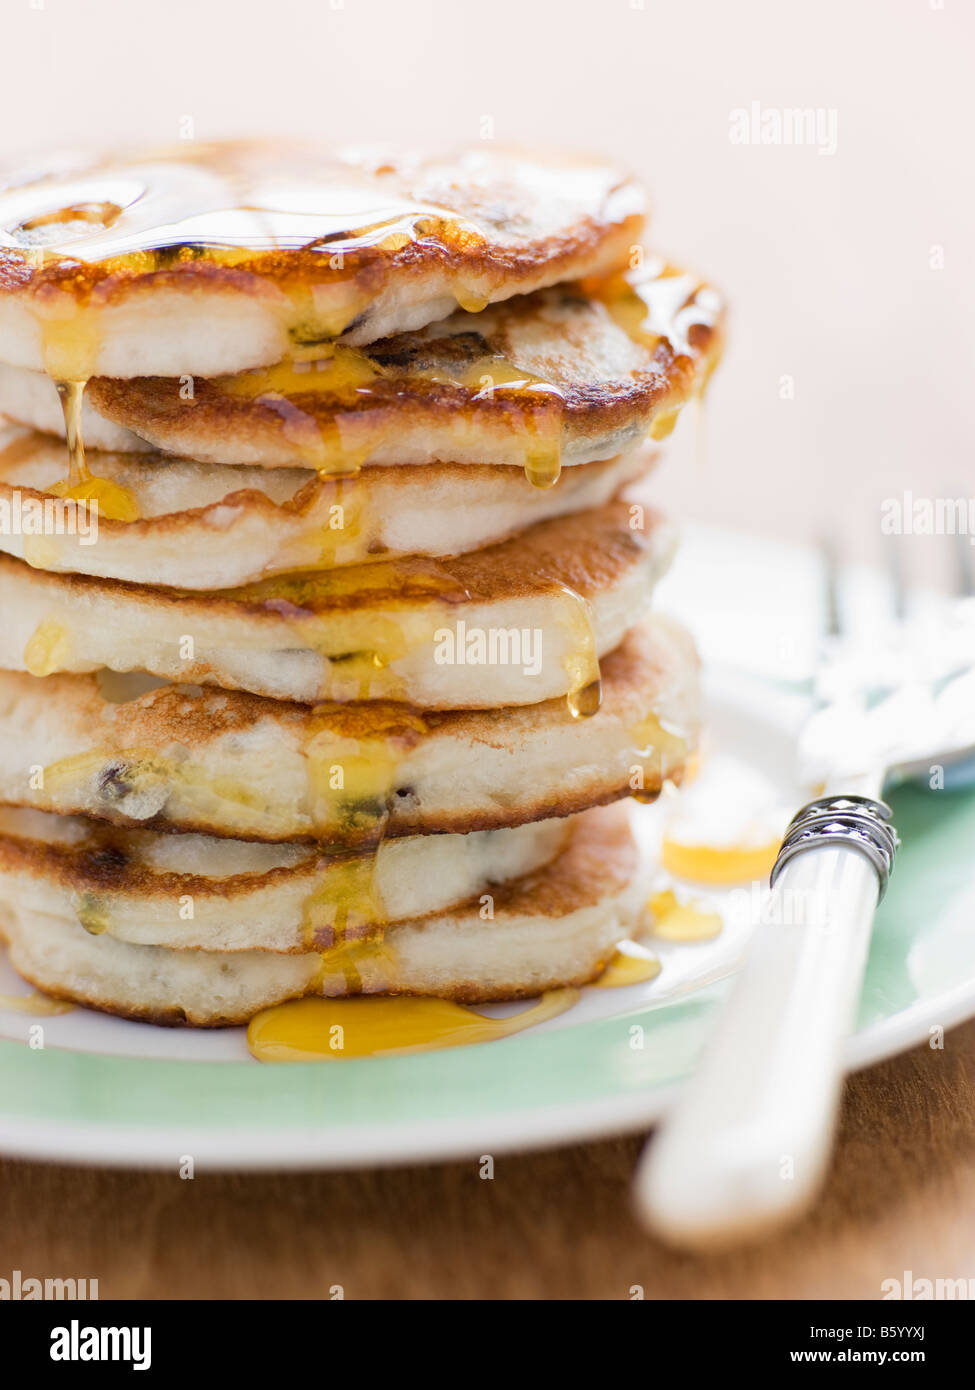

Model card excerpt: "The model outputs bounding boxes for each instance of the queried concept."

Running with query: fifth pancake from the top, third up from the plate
[0,617,700,842]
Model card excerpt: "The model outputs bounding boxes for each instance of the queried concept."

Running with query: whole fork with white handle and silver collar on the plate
[634,538,975,1248]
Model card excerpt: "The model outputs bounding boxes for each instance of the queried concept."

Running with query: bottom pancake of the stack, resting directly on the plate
[0,808,645,1026]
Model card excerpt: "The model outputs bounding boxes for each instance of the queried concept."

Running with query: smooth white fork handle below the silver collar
[636,844,879,1248]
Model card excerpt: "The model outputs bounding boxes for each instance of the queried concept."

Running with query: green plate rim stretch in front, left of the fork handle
[0,997,707,1129]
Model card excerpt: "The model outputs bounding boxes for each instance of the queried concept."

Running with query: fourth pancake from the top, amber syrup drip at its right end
[0,500,676,713]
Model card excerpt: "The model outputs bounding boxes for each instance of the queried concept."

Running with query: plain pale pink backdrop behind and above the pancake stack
[0,0,975,577]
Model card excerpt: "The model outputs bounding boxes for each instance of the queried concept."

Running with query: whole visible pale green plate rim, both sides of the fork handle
[0,787,975,1141]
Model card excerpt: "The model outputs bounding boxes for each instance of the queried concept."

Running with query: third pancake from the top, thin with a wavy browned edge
[0,430,652,589]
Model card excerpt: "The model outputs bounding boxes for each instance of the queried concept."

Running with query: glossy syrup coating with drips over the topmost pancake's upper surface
[0,140,644,364]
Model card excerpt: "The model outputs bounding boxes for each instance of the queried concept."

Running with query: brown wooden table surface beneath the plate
[0,1022,975,1300]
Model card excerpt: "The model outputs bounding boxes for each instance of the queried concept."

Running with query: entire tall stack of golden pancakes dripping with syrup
[0,143,722,1024]
